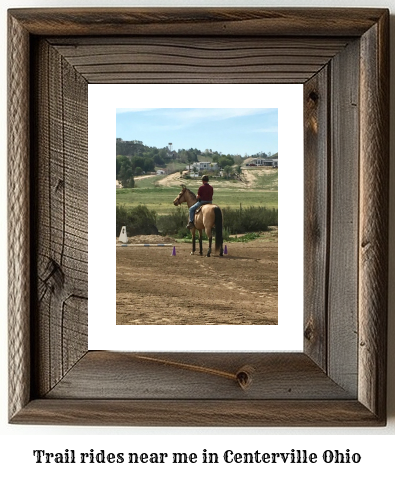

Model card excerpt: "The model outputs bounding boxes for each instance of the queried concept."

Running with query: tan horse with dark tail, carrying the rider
[173,186,224,257]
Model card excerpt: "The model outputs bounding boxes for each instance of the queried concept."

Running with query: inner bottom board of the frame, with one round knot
[46,351,356,400]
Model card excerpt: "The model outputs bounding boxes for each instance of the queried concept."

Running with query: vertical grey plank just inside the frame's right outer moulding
[327,41,359,393]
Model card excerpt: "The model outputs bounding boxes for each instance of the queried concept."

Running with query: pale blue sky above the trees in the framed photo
[116,108,278,156]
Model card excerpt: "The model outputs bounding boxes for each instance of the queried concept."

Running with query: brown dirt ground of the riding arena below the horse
[116,232,278,325]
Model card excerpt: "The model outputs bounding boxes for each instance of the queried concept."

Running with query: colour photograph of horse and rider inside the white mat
[116,108,278,325]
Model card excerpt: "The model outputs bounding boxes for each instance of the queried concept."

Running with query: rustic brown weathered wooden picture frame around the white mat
[8,8,389,426]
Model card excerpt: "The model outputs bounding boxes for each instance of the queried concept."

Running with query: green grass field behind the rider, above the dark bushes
[116,167,278,215]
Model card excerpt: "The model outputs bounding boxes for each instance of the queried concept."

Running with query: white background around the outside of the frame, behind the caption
[0,0,395,477]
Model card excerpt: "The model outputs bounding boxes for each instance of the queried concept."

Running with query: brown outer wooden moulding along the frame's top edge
[10,8,385,38]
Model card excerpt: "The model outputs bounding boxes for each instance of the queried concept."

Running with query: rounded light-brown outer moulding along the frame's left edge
[8,13,31,417]
